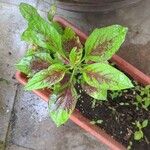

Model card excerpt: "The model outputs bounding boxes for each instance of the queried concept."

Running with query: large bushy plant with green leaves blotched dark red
[17,3,133,126]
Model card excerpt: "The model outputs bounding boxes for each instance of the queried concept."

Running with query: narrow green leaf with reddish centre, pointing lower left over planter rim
[25,64,66,90]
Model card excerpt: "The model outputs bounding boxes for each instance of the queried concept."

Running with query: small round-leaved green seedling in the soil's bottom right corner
[133,119,148,141]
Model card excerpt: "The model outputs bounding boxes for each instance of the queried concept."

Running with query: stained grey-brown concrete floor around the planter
[0,0,150,150]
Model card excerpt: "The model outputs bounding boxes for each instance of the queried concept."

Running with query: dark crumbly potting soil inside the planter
[76,85,150,150]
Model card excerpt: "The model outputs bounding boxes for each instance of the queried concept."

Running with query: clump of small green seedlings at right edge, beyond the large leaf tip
[134,85,150,110]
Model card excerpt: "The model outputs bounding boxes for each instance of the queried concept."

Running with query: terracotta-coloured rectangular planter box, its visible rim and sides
[16,17,150,150]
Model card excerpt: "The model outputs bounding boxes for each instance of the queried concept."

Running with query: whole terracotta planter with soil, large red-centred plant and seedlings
[16,3,150,150]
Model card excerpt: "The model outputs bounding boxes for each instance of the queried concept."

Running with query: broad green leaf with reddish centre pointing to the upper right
[85,25,127,62]
